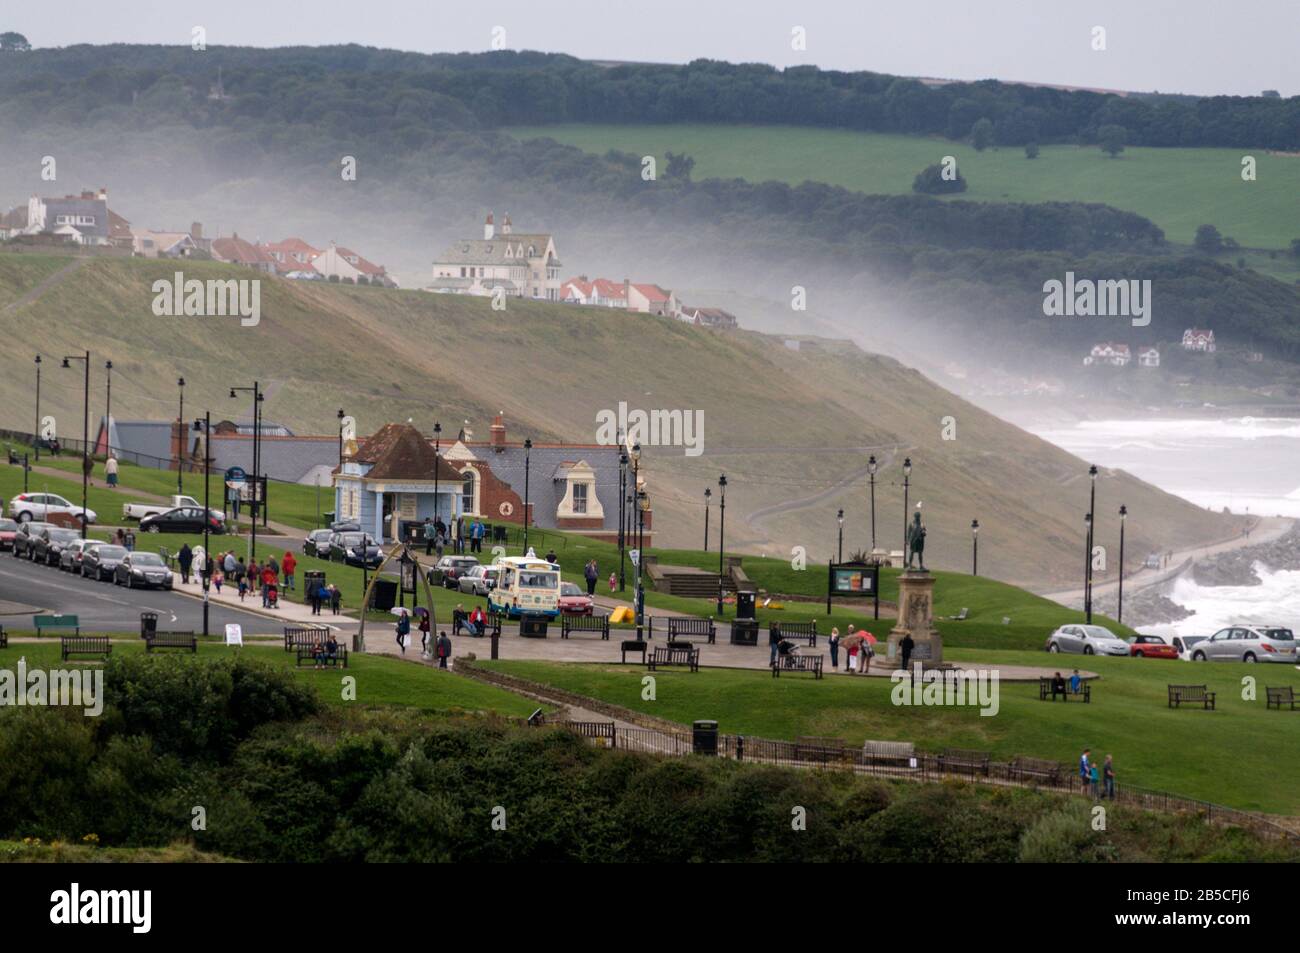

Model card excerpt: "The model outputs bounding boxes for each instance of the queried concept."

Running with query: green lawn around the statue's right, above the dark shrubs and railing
[481,647,1300,814]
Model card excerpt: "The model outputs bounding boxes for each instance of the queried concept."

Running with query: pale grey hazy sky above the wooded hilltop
[0,0,1300,96]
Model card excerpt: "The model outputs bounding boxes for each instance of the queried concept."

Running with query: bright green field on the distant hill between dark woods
[504,124,1300,252]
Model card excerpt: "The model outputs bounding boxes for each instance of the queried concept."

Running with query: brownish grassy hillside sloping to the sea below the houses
[0,256,1234,586]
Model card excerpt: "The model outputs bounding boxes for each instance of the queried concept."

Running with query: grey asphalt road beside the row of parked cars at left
[0,553,280,634]
